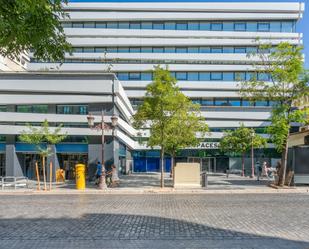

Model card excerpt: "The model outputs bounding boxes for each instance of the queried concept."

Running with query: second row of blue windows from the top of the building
[73,46,275,54]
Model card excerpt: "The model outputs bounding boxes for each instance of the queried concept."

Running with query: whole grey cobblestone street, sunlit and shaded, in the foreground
[0,194,309,249]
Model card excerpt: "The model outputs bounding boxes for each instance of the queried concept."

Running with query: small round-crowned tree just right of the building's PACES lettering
[220,124,267,176]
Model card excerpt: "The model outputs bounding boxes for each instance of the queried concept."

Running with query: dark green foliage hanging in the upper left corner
[0,0,71,61]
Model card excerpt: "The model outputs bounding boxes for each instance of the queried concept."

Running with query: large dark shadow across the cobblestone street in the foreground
[0,212,309,249]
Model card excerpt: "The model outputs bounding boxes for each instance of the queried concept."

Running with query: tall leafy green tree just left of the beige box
[133,66,207,187]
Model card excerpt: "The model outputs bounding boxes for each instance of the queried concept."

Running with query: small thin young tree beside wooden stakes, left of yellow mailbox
[19,120,67,190]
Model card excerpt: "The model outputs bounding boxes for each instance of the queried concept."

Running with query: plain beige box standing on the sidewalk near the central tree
[174,163,201,188]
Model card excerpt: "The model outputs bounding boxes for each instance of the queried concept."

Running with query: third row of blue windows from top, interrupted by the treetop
[116,72,270,81]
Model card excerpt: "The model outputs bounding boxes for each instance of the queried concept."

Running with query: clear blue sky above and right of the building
[69,0,309,69]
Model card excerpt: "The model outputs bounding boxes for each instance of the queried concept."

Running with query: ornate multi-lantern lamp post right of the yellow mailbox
[87,110,118,189]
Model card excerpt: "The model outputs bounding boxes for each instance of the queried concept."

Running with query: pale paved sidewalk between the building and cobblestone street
[0,174,309,195]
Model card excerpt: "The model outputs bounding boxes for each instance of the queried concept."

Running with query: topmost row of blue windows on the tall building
[62,21,295,32]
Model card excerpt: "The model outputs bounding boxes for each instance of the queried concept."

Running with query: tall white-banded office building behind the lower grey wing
[0,1,304,177]
